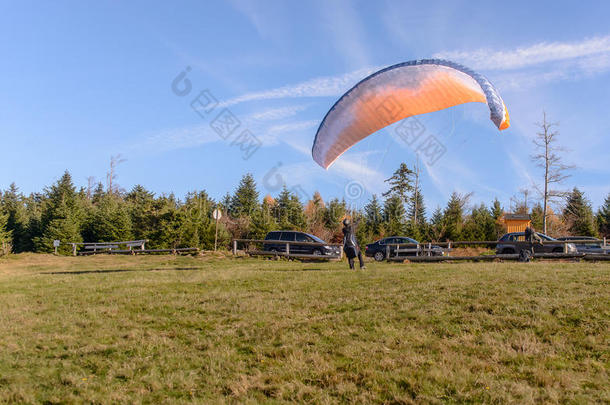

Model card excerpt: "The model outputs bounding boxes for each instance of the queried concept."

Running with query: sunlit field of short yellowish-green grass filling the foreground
[0,255,610,404]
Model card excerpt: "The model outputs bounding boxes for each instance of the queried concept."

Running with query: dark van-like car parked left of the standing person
[263,231,341,256]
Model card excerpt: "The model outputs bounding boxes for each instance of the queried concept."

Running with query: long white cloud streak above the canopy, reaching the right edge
[434,36,610,70]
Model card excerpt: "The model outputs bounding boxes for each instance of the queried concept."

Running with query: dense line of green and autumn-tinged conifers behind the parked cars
[0,163,610,253]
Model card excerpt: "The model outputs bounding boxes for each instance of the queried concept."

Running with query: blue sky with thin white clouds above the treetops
[0,0,610,213]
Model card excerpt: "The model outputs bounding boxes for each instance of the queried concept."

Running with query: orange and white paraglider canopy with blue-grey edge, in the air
[312,59,510,169]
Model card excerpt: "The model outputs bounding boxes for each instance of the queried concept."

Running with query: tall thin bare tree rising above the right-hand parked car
[531,111,574,233]
